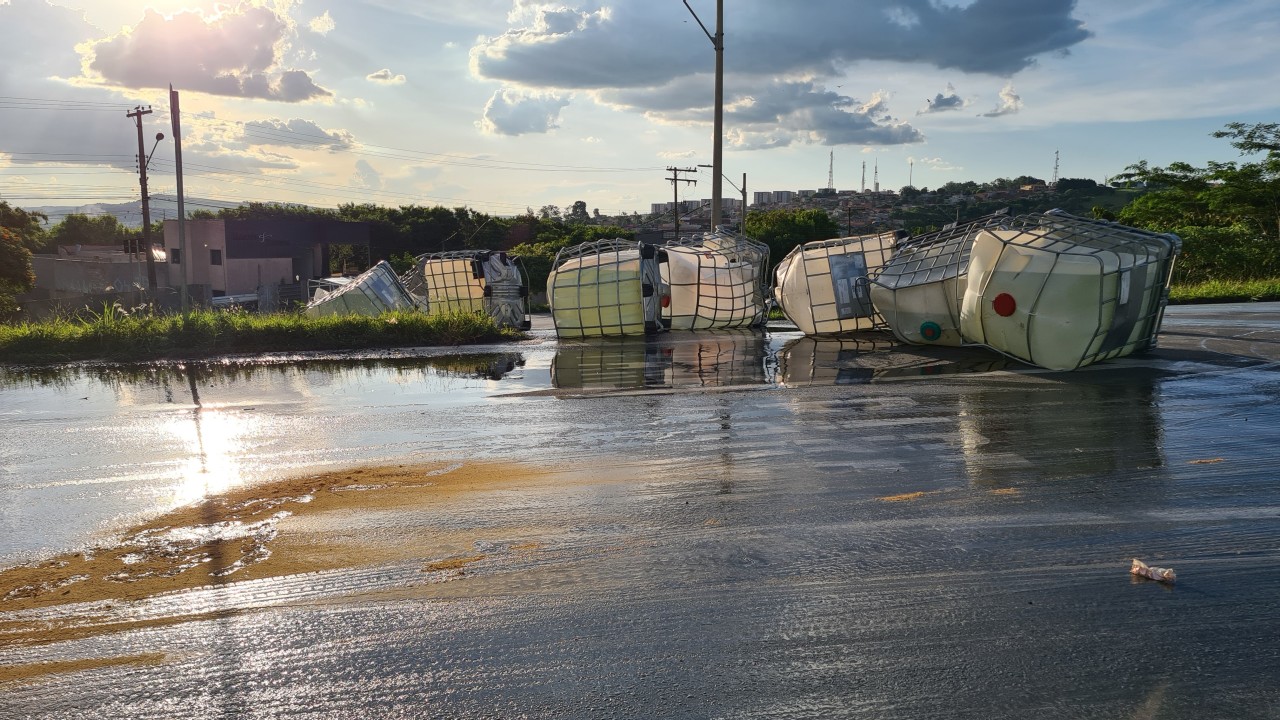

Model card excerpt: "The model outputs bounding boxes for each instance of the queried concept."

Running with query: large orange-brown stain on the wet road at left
[0,462,563,648]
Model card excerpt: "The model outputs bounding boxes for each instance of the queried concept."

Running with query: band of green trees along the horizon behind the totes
[0,123,1280,313]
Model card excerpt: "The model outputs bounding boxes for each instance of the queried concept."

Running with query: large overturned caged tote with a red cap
[960,211,1180,370]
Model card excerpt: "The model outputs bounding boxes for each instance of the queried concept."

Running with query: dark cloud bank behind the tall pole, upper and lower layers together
[470,0,1089,146]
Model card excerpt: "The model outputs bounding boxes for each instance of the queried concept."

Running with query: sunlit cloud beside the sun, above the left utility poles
[87,5,333,102]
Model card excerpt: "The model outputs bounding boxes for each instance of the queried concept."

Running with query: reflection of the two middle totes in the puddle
[552,331,771,389]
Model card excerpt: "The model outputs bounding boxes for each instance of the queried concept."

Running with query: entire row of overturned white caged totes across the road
[308,210,1181,370]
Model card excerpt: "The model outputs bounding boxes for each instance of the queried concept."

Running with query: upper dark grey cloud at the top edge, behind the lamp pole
[471,0,1089,88]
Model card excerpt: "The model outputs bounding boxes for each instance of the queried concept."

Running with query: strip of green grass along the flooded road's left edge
[0,306,521,364]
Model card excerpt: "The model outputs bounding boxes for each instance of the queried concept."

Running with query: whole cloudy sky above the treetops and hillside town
[0,0,1280,215]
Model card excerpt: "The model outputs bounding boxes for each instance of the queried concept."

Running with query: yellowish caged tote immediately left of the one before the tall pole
[547,240,662,337]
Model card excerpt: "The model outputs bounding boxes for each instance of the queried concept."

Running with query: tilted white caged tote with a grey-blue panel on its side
[773,233,897,334]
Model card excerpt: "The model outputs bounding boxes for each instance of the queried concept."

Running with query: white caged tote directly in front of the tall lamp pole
[659,231,769,331]
